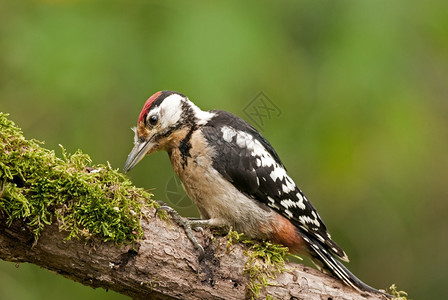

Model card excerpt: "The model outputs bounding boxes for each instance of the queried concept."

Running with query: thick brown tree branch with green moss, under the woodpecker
[0,114,385,299]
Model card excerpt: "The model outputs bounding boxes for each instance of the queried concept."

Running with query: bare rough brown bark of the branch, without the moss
[0,204,385,299]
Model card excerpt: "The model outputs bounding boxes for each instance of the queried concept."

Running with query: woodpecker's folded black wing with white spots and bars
[202,111,347,260]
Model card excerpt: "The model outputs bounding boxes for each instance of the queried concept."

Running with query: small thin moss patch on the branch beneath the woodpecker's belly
[227,229,301,299]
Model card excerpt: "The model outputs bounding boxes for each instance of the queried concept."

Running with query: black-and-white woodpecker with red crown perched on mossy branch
[123,91,382,293]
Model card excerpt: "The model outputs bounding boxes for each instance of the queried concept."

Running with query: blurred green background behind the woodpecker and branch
[0,0,448,300]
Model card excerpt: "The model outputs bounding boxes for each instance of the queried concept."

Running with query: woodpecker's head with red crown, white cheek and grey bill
[123,91,212,172]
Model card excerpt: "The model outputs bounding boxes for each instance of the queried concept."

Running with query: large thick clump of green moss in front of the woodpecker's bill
[0,113,153,244]
